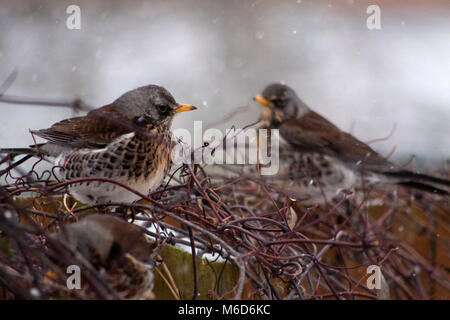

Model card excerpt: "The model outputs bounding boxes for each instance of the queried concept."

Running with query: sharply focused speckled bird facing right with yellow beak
[0,85,196,205]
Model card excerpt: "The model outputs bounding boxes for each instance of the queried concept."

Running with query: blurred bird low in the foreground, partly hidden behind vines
[49,214,157,299]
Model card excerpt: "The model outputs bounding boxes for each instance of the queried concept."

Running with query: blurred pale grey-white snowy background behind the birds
[0,0,450,169]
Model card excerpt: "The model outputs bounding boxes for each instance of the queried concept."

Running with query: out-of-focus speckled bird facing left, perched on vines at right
[253,83,450,203]
